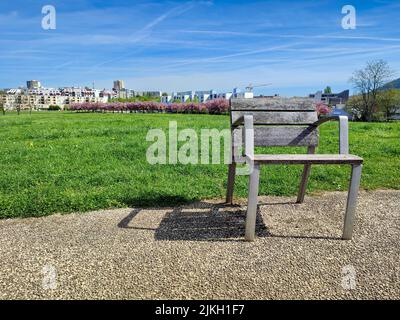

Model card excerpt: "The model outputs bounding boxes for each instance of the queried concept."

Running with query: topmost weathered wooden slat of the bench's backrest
[230,98,315,111]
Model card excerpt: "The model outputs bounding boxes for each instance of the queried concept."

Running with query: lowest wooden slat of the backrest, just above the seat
[233,126,319,147]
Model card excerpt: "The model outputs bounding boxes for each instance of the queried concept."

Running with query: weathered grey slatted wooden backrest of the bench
[230,98,319,157]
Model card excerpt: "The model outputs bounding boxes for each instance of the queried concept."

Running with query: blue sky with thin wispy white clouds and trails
[0,0,400,96]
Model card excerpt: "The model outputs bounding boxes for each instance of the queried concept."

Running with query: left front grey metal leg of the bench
[245,163,260,241]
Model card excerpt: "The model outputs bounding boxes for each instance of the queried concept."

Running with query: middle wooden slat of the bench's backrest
[231,111,318,125]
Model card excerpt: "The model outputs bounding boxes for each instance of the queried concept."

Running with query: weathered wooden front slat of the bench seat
[254,154,363,164]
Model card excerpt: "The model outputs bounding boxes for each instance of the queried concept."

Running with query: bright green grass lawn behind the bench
[0,112,400,218]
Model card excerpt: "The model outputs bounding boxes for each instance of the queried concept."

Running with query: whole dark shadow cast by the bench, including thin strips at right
[118,195,340,241]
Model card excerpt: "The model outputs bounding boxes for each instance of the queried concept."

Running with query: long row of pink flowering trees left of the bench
[68,99,229,114]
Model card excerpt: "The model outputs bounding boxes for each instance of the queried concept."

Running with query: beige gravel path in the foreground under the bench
[0,191,400,299]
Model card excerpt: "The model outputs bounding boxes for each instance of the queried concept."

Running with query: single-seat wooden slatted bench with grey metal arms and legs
[226,98,363,241]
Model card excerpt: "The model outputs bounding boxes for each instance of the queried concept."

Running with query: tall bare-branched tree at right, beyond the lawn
[350,60,394,121]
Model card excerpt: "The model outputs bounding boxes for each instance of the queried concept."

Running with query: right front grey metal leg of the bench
[342,164,362,240]
